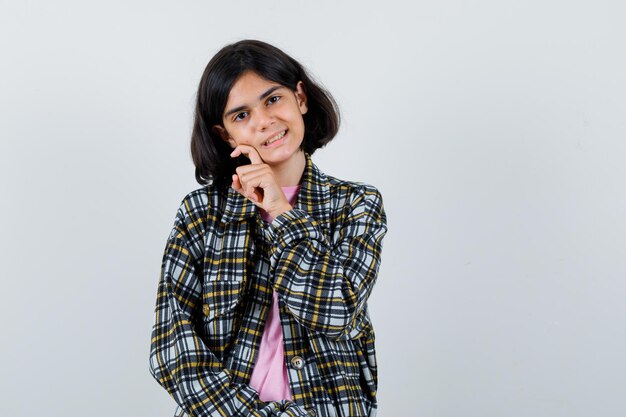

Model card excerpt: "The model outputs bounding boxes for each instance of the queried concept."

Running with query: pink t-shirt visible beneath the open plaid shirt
[250,185,300,402]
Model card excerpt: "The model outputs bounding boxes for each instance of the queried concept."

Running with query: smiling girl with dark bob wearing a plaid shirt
[150,40,387,417]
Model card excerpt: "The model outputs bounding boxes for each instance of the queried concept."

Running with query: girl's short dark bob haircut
[191,39,340,186]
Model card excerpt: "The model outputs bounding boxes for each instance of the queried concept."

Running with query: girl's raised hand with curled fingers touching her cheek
[230,145,293,218]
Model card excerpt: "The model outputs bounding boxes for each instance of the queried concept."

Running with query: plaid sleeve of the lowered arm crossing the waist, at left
[150,197,307,417]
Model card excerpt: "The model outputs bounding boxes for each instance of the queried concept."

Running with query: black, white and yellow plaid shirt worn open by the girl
[150,154,387,417]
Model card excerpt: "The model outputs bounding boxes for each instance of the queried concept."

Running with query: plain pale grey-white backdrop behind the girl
[0,0,626,417]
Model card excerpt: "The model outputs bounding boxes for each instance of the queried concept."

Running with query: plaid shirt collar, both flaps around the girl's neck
[222,152,331,227]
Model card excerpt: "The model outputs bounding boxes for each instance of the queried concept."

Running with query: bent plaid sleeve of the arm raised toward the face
[270,184,387,339]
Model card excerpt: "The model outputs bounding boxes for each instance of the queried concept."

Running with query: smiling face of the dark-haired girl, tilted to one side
[214,71,307,166]
